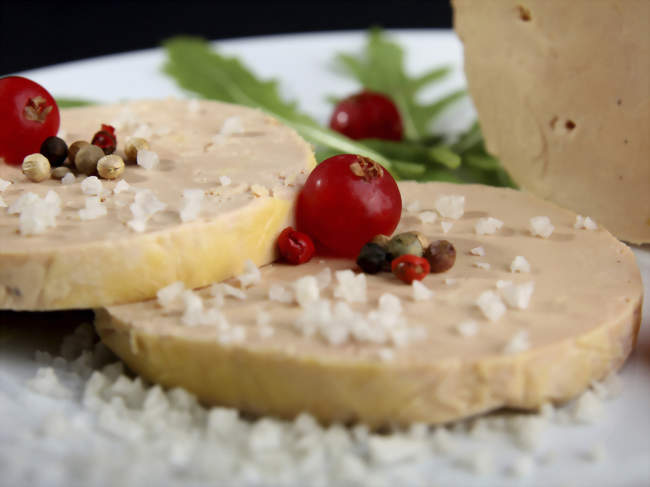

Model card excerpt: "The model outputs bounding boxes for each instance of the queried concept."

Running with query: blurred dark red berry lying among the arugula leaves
[330,91,404,140]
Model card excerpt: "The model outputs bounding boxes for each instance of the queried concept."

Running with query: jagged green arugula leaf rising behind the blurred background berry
[335,29,466,140]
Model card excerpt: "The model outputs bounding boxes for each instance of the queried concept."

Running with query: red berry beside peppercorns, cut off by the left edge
[0,76,60,165]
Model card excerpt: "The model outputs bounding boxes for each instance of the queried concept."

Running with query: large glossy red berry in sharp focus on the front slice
[296,154,402,259]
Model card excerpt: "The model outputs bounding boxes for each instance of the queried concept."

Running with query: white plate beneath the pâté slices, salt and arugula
[0,31,650,487]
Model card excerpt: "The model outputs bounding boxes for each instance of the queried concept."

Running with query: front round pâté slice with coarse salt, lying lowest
[96,183,643,426]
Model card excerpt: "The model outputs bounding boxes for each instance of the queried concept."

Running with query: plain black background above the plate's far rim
[0,0,451,75]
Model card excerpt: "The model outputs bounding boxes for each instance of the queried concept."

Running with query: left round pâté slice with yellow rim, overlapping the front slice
[0,99,315,310]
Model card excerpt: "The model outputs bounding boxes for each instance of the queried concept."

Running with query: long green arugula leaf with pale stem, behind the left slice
[164,37,390,169]
